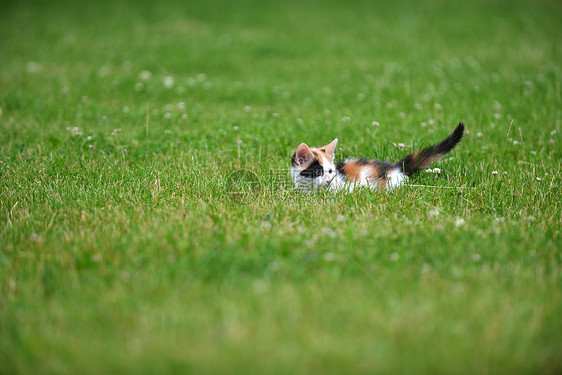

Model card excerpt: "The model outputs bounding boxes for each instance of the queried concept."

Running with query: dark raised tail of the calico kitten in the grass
[396,121,464,176]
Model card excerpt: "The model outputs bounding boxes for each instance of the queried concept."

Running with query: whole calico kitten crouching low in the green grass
[291,122,464,192]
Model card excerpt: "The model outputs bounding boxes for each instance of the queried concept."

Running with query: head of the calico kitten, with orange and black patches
[291,138,338,190]
